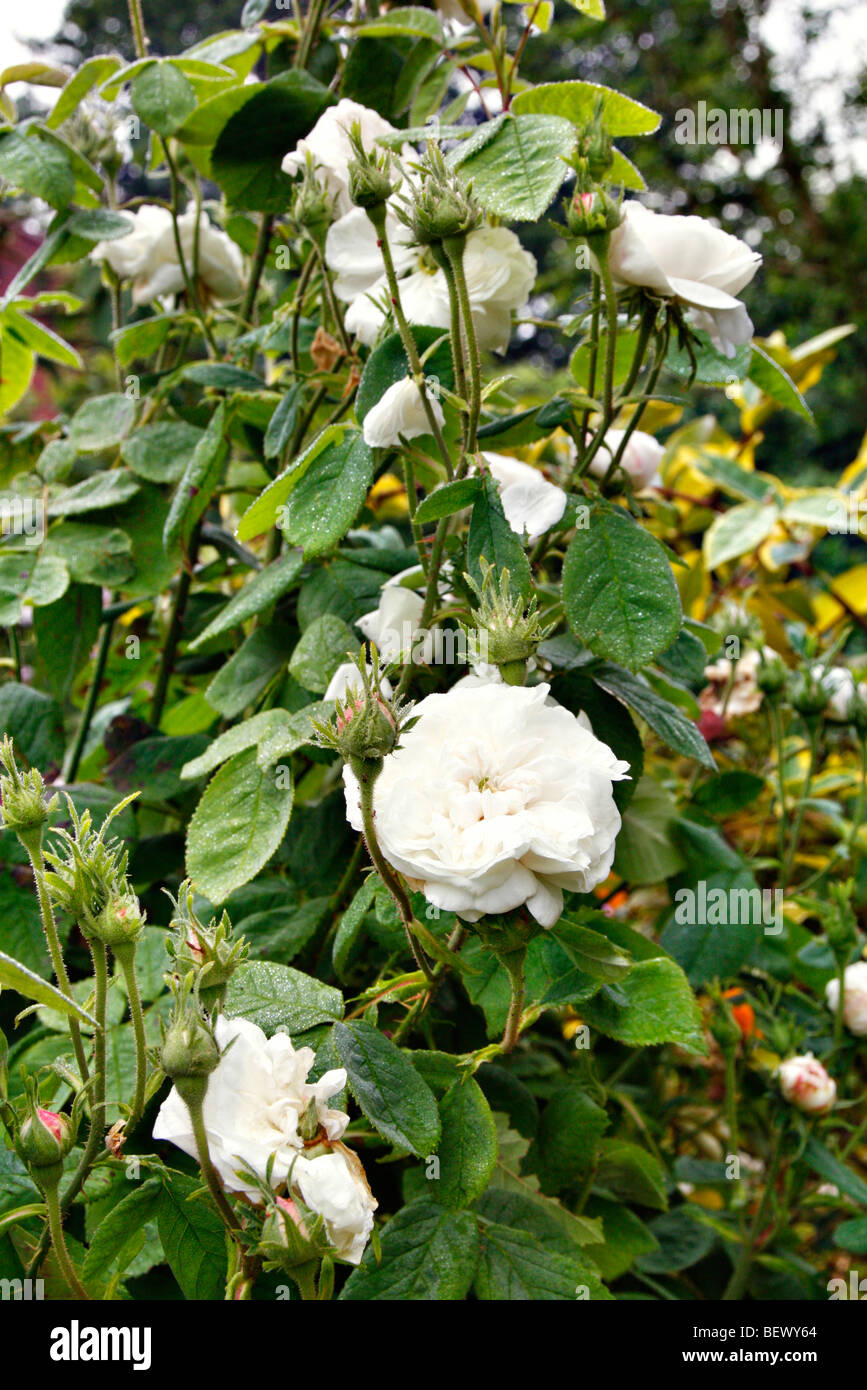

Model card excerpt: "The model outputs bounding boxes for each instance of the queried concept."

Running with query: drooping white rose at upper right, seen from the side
[609,200,761,357]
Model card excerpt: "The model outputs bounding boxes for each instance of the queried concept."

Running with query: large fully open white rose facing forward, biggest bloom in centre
[343,684,629,927]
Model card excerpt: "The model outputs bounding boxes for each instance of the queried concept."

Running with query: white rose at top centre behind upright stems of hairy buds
[325,218,536,352]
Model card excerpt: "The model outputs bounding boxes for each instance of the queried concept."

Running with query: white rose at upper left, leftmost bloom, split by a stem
[132,209,245,304]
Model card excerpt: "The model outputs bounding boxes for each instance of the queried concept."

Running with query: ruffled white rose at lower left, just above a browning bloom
[153,1015,349,1200]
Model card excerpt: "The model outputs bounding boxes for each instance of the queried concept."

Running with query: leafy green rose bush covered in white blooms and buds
[0,0,867,1305]
